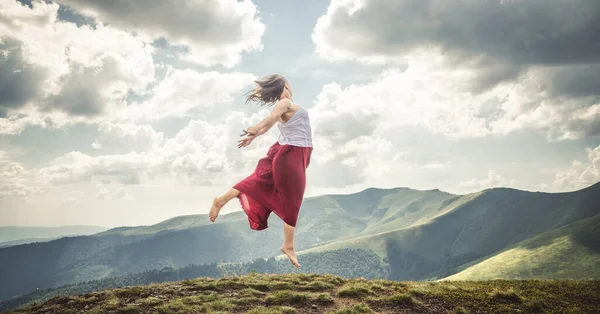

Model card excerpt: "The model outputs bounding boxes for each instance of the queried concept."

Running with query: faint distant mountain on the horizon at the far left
[0,226,108,246]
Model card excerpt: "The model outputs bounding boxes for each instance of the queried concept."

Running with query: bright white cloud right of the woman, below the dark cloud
[313,52,600,142]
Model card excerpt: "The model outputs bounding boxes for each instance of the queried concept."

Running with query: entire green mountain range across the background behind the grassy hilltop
[0,183,600,299]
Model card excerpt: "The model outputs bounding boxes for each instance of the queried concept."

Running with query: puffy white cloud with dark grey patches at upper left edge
[0,0,154,133]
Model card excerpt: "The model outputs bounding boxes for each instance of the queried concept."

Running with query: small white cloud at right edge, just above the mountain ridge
[542,145,600,192]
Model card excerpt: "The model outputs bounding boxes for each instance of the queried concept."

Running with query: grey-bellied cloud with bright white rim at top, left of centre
[58,0,265,67]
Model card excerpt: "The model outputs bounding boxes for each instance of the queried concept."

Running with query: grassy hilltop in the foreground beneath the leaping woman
[8,274,600,314]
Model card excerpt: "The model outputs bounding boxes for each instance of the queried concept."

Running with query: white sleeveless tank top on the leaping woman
[277,107,312,147]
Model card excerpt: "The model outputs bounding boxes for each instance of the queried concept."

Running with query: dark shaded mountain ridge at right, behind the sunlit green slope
[300,183,600,280]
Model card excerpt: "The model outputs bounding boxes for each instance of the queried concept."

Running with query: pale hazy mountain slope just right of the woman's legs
[295,188,458,249]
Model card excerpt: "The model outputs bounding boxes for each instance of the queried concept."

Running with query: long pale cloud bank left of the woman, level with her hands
[39,109,275,188]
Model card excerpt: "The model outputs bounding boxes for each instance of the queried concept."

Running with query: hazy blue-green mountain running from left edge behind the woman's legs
[0,188,452,299]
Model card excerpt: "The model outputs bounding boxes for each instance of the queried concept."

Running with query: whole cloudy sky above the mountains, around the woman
[0,0,600,227]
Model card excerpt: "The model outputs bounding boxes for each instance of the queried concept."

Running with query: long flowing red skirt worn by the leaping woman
[233,142,313,230]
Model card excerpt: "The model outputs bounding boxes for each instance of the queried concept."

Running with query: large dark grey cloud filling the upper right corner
[325,0,600,64]
